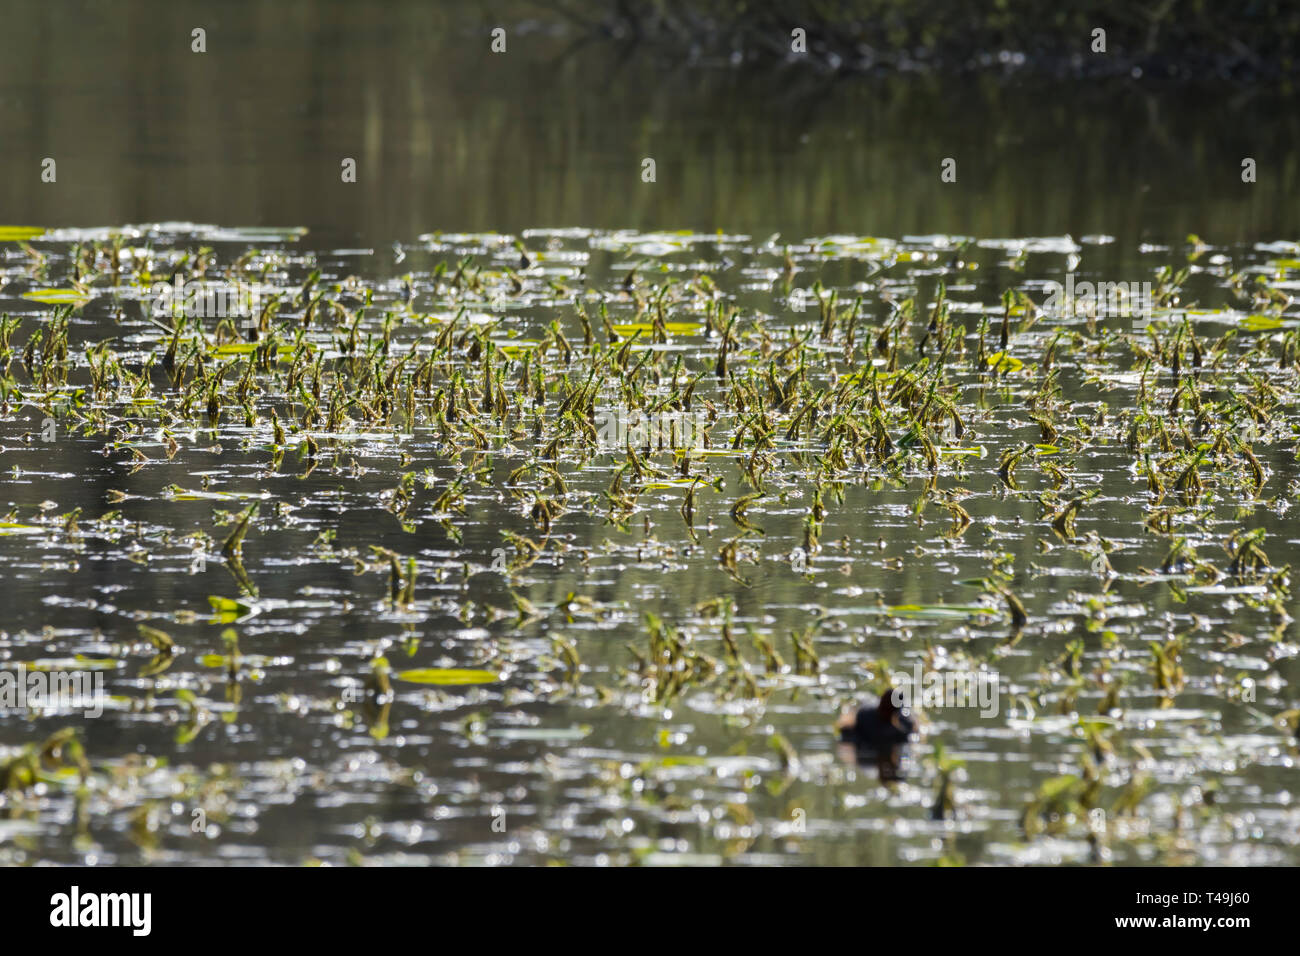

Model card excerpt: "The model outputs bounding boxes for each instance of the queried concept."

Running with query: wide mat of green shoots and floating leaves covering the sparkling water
[0,226,1300,862]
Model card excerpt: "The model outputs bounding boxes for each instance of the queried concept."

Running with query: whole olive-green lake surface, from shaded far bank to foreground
[0,4,1300,864]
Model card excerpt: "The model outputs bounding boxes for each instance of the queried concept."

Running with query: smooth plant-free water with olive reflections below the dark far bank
[0,0,1300,250]
